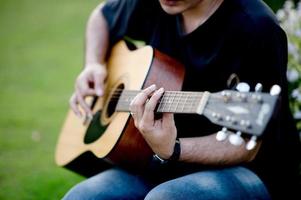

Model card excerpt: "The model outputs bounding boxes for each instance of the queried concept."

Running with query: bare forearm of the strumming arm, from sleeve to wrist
[85,4,109,66]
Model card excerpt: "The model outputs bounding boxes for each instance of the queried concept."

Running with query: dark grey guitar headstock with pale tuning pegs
[202,83,281,148]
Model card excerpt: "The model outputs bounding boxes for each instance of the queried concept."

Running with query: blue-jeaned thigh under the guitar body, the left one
[63,168,151,200]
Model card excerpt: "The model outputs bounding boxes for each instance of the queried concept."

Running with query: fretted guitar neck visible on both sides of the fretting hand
[115,90,208,114]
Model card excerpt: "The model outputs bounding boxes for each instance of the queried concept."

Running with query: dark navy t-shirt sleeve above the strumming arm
[101,0,159,44]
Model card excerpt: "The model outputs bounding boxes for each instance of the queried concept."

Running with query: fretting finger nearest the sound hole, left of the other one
[130,85,156,121]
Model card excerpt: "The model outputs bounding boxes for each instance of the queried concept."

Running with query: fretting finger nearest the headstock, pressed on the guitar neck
[142,88,164,124]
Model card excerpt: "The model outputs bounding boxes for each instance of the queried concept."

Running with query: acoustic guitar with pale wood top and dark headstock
[55,41,277,176]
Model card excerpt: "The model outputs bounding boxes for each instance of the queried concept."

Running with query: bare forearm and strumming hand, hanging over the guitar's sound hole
[69,3,109,118]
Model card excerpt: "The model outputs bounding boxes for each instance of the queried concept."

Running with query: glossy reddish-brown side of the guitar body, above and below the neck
[106,50,185,171]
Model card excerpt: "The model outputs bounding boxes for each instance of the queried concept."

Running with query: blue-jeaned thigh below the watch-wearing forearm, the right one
[145,167,270,200]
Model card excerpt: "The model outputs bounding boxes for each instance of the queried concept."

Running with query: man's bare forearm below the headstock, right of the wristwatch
[180,134,260,166]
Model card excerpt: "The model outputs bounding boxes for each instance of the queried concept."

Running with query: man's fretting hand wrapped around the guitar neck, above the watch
[130,85,177,159]
